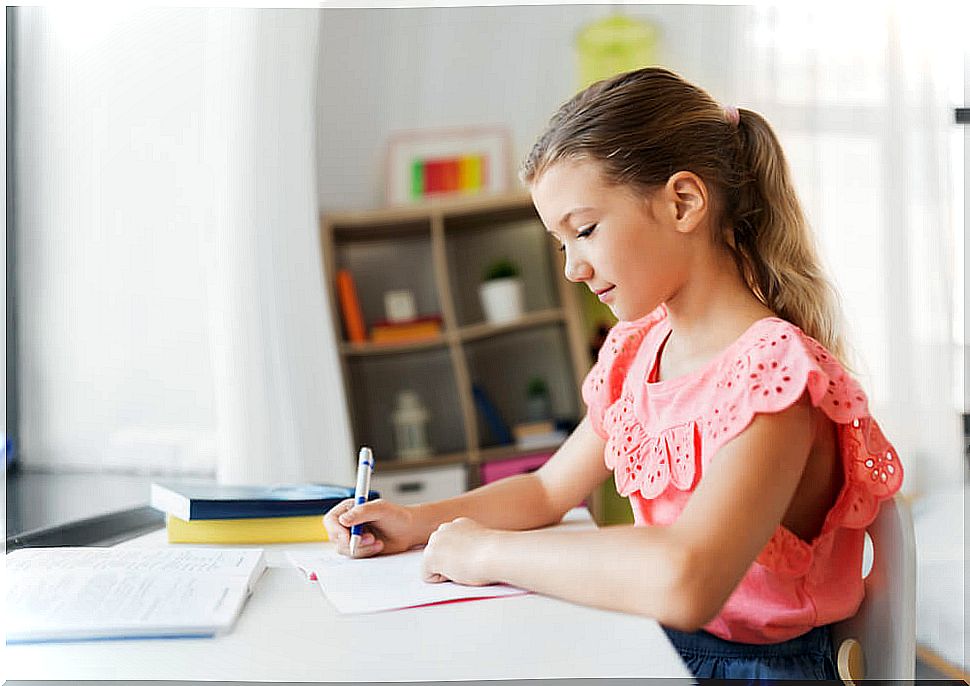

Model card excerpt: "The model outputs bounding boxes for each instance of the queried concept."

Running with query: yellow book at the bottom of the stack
[165,515,328,544]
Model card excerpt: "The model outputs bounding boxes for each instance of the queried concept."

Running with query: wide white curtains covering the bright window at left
[12,5,354,483]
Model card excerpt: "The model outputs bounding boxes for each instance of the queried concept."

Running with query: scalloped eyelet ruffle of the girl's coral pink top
[604,317,903,536]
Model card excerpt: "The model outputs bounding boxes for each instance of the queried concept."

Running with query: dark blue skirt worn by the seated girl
[664,626,839,680]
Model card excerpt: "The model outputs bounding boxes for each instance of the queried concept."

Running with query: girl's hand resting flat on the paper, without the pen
[422,517,502,586]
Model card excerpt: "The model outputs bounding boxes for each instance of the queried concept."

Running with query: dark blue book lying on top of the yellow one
[151,479,380,521]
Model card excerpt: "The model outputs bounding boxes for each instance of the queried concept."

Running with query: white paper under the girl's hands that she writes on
[288,549,528,614]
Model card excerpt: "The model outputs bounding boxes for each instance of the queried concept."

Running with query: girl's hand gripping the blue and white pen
[323,498,421,557]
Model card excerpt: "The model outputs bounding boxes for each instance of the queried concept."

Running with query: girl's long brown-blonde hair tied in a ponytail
[519,67,847,362]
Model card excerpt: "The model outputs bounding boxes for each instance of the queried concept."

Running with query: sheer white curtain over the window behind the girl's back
[721,3,968,494]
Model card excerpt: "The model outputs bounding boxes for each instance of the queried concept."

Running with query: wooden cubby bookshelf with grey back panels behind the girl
[320,193,592,516]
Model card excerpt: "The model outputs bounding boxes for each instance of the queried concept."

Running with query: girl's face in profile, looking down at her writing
[532,160,688,320]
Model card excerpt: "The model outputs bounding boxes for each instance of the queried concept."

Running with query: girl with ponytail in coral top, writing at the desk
[325,68,902,679]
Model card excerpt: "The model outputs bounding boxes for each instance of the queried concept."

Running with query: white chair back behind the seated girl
[832,495,916,684]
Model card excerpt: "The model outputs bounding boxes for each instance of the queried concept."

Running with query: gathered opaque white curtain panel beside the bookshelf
[203,8,353,483]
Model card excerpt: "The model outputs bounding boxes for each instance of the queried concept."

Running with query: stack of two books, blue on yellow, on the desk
[151,480,378,545]
